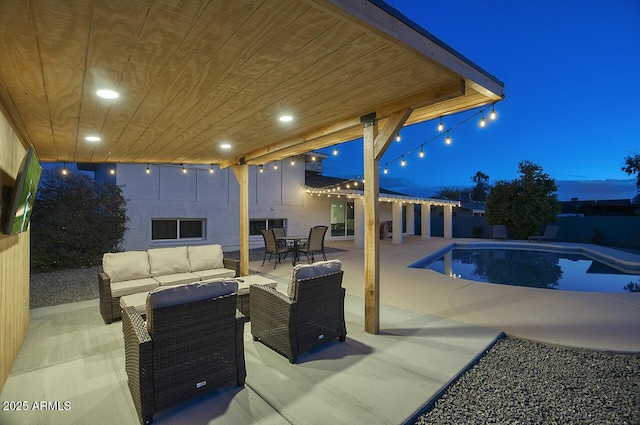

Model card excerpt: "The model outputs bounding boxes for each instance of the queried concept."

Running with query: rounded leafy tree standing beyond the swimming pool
[485,161,562,239]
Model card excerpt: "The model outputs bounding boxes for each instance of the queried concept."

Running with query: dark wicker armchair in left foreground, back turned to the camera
[122,279,246,424]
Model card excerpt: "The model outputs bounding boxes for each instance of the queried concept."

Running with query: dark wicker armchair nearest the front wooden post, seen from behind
[249,260,347,363]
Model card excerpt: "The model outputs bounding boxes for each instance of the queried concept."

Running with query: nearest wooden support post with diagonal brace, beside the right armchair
[360,109,412,334]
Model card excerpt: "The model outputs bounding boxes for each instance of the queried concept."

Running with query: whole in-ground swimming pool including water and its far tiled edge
[409,243,640,292]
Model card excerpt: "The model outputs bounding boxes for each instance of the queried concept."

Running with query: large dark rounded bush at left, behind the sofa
[30,170,128,270]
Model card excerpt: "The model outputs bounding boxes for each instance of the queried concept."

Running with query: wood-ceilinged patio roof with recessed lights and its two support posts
[0,0,504,333]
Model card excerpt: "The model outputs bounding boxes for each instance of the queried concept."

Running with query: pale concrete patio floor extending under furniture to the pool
[0,237,640,424]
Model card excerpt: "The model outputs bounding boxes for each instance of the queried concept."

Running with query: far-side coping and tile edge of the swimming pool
[407,241,640,274]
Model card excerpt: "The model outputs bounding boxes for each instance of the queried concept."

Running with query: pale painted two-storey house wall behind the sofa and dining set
[118,160,316,251]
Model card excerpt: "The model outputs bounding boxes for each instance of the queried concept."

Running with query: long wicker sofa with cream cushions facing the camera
[98,244,240,324]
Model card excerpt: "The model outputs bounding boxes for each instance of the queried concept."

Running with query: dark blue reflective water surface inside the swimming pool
[420,248,640,292]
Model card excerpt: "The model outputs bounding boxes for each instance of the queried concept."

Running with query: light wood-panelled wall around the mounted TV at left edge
[0,114,30,391]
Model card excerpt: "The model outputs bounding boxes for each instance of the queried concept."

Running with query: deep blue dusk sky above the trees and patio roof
[320,0,640,200]
